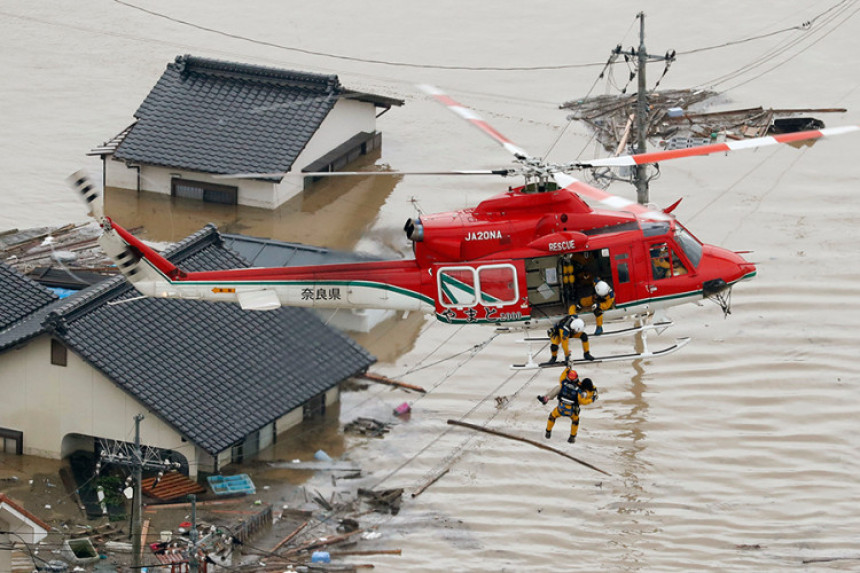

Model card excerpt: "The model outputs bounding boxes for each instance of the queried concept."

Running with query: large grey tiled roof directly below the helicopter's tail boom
[0,227,375,454]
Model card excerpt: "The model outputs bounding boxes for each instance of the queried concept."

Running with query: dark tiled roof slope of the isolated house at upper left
[115,56,343,178]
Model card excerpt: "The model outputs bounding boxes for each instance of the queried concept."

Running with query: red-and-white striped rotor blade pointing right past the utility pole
[578,125,860,167]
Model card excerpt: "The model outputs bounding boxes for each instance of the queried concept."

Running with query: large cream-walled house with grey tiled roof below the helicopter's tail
[0,226,375,476]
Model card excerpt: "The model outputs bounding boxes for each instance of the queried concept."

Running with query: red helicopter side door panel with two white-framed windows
[432,260,530,323]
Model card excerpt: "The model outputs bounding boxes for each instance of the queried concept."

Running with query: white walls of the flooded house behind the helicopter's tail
[105,99,376,209]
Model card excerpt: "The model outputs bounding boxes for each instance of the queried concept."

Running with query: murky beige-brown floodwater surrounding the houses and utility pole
[0,0,860,572]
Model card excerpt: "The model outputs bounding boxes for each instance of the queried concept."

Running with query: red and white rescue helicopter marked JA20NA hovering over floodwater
[69,86,860,366]
